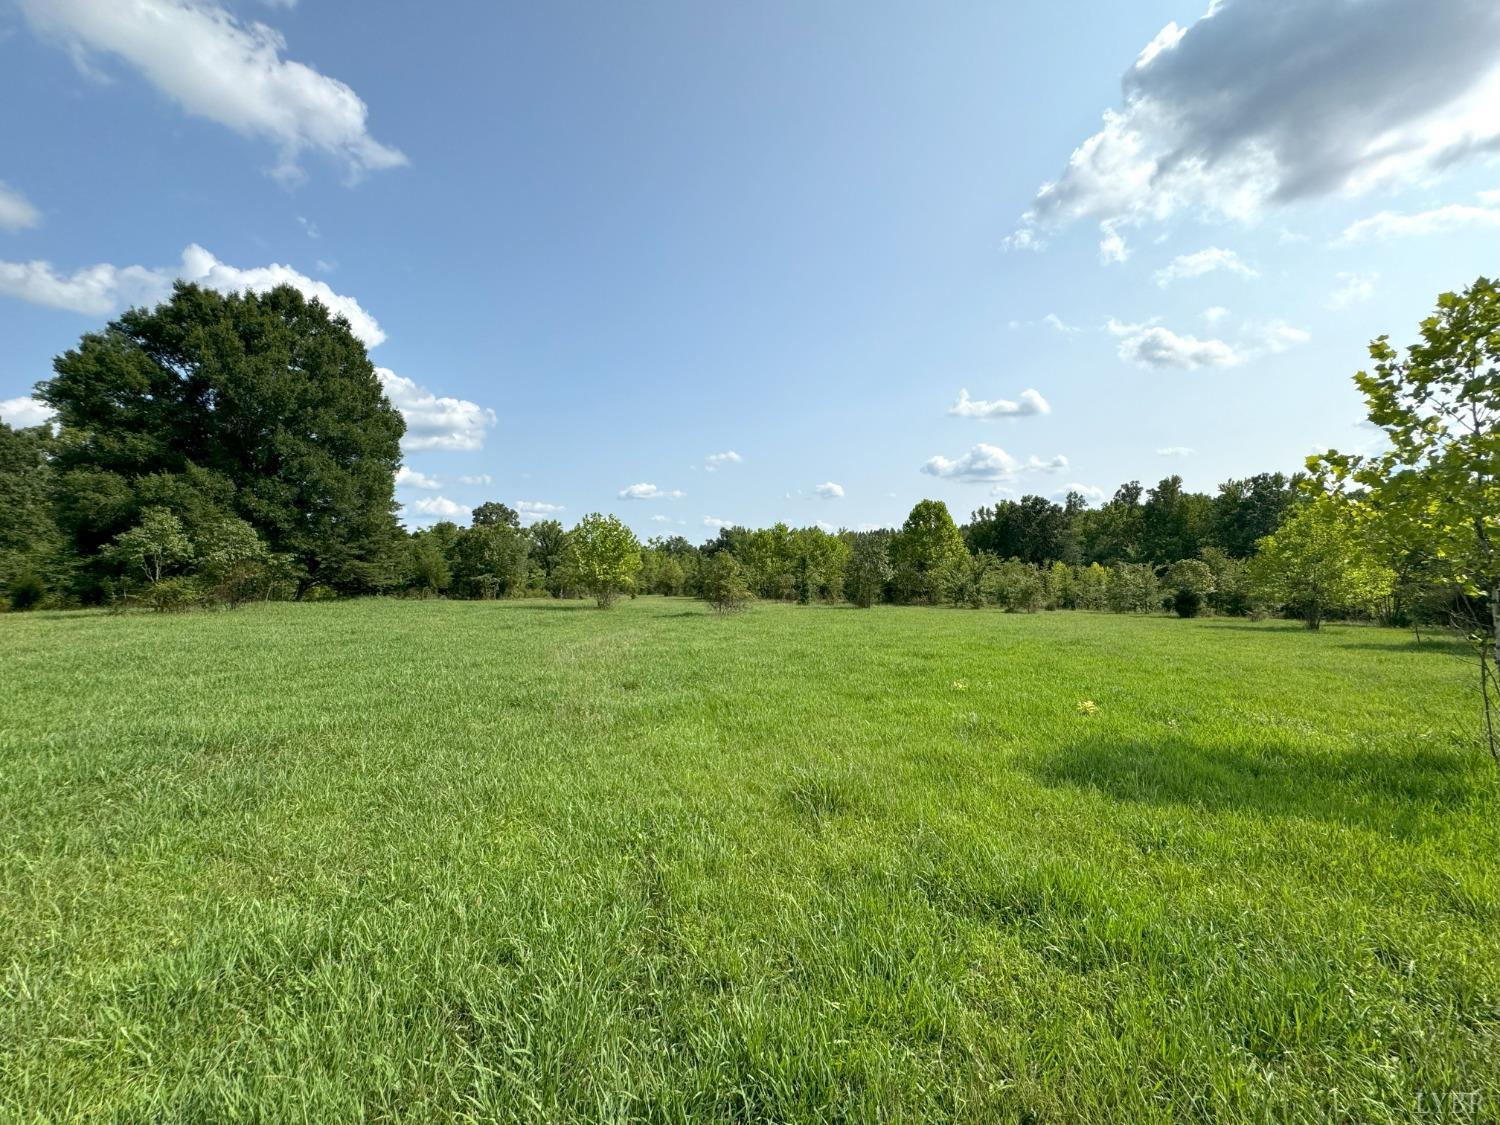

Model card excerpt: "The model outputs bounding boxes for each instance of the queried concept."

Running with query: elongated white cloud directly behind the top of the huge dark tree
[0,243,386,348]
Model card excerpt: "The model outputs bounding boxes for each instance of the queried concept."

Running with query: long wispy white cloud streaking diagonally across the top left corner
[20,0,407,180]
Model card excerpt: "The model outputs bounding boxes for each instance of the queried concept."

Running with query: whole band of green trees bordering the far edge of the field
[0,279,1500,666]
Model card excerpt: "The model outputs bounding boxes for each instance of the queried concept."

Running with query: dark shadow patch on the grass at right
[1026,740,1490,836]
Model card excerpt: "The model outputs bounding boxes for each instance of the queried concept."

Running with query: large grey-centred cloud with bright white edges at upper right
[1008,0,1500,249]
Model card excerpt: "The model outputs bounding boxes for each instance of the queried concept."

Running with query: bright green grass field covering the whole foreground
[0,599,1500,1122]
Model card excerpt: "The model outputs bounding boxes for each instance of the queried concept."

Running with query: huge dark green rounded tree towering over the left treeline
[38,284,405,593]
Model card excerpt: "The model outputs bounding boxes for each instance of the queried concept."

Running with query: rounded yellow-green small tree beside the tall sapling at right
[1250,495,1392,629]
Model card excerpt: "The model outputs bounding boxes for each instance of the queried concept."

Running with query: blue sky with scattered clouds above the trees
[0,0,1500,539]
